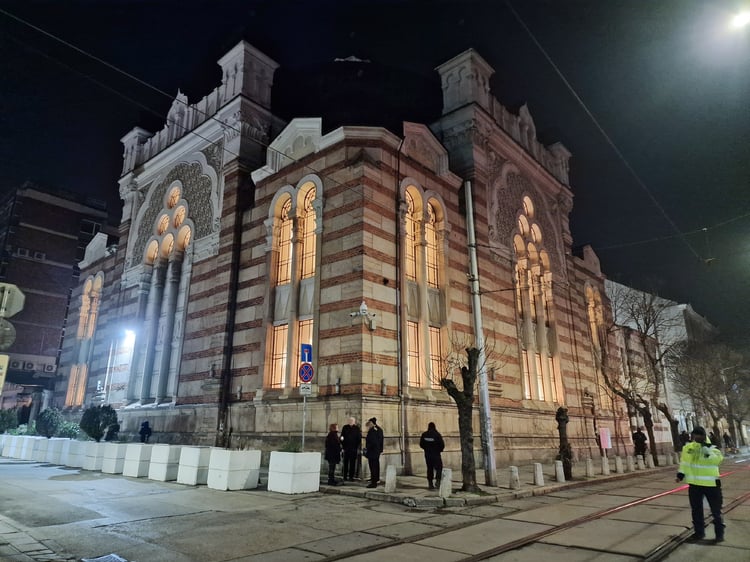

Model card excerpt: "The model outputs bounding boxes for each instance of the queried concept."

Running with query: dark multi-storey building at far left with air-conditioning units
[0,184,107,421]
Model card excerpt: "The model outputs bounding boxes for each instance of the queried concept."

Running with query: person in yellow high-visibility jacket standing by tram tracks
[677,426,724,543]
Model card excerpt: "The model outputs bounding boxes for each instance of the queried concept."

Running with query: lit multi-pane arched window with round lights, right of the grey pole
[513,197,561,401]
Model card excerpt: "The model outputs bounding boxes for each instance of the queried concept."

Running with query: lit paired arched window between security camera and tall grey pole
[401,182,447,388]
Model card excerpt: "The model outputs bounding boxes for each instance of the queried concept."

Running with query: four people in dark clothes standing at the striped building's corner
[324,417,445,490]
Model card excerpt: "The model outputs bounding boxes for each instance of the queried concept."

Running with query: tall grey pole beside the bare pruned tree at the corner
[464,181,497,486]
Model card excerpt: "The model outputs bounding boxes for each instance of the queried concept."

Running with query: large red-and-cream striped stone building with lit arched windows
[56,42,640,470]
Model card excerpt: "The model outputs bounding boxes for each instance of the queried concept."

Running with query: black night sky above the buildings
[0,0,750,339]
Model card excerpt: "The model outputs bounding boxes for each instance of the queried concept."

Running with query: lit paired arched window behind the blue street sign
[265,178,322,388]
